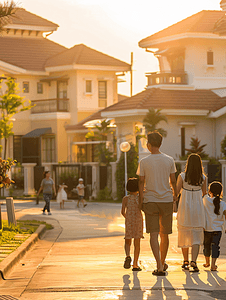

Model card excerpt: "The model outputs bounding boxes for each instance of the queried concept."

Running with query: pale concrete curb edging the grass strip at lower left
[0,224,46,281]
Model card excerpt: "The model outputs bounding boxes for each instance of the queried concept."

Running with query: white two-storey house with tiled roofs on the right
[97,1,226,164]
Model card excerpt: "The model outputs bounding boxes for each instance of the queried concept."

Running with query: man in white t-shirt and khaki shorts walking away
[137,132,177,276]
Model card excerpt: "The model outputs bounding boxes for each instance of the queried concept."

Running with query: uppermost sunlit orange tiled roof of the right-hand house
[139,10,225,47]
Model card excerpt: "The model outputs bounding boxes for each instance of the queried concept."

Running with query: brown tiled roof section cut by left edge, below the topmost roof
[0,37,66,71]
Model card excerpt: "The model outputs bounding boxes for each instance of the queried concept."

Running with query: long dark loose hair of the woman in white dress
[185,153,204,186]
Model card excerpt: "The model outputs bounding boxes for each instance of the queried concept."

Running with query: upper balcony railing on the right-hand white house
[146,72,188,86]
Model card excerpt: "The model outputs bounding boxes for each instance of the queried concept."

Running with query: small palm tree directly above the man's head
[143,108,168,137]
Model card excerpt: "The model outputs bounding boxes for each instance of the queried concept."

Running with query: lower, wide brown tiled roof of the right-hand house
[103,88,226,113]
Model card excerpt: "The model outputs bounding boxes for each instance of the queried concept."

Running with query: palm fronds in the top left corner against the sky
[0,0,19,32]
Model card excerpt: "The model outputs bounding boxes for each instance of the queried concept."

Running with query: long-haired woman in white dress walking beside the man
[177,153,206,272]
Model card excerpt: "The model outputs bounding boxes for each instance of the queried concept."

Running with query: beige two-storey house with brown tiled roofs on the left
[0,9,130,165]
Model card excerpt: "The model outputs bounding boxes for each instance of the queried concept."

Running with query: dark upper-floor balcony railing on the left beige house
[31,98,69,114]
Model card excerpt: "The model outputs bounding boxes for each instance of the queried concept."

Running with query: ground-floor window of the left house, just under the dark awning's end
[42,136,56,162]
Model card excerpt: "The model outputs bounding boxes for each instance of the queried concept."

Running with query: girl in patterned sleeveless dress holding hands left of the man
[121,178,143,271]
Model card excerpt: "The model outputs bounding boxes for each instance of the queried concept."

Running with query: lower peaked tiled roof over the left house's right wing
[46,44,130,68]
